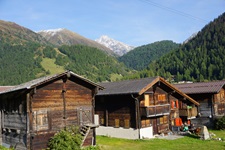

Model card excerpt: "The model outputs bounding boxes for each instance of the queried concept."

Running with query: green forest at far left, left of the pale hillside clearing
[0,41,47,85]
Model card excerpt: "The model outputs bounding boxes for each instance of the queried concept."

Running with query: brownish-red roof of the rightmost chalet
[174,80,225,94]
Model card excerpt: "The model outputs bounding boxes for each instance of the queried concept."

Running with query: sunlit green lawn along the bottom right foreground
[97,130,225,150]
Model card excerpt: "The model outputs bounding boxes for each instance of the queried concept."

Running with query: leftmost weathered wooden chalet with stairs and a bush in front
[0,71,102,150]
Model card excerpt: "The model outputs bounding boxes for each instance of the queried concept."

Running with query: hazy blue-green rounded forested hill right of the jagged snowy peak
[119,40,179,70]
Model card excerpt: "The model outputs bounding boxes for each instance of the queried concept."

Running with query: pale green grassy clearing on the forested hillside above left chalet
[41,58,65,74]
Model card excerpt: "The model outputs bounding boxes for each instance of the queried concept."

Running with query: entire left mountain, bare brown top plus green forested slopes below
[0,21,130,85]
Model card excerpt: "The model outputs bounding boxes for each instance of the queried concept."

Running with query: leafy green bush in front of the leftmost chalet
[48,126,82,150]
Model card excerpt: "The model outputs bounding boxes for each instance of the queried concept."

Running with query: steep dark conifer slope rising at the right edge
[124,13,225,81]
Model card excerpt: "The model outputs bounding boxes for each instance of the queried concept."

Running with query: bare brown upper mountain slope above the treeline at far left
[0,20,49,44]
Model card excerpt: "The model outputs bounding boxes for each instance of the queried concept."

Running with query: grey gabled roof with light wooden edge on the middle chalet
[97,77,199,105]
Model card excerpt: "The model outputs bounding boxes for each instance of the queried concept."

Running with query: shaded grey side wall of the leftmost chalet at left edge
[0,92,27,149]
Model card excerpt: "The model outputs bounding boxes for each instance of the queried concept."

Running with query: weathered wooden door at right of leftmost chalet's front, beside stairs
[77,106,93,125]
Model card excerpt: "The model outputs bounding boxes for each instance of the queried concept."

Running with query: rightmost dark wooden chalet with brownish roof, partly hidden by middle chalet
[175,81,225,127]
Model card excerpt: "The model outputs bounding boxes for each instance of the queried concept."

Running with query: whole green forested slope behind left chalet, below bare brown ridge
[0,38,129,85]
